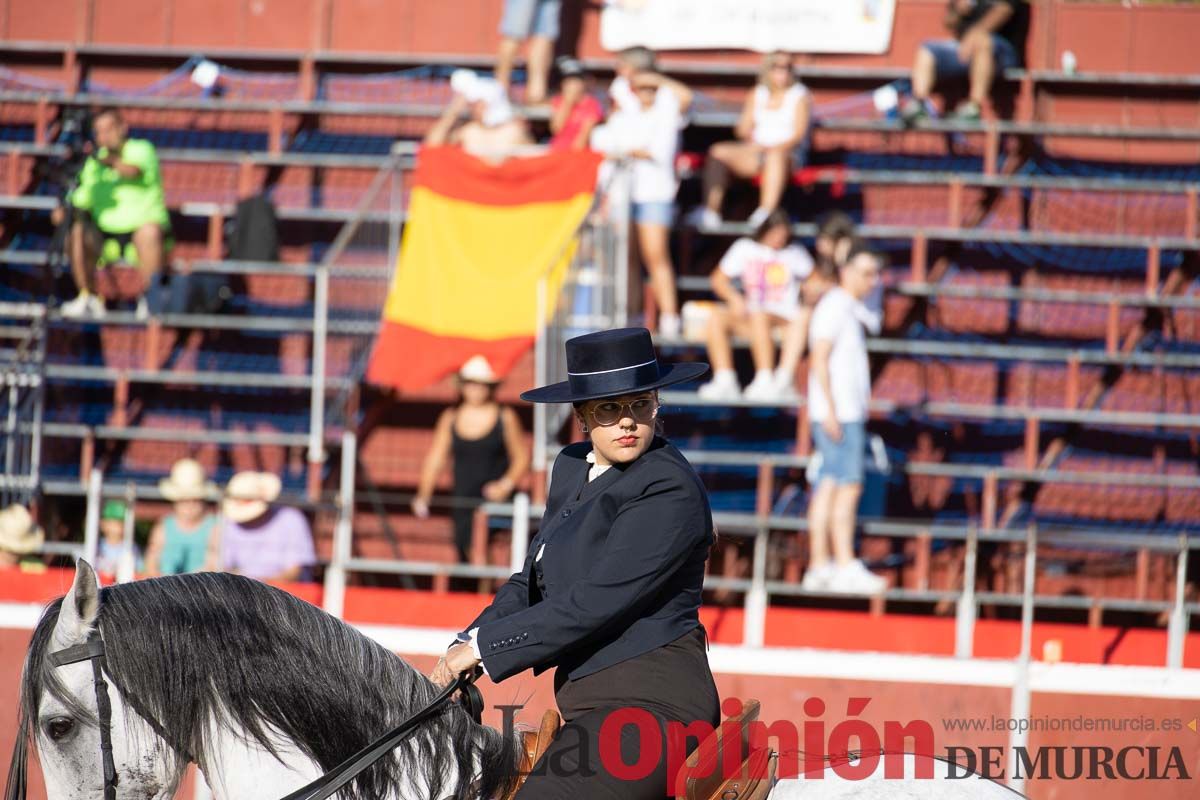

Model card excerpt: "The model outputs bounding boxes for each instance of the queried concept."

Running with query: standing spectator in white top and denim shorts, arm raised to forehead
[592,65,692,337]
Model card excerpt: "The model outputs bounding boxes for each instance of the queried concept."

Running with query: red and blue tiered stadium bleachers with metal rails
[0,3,1200,633]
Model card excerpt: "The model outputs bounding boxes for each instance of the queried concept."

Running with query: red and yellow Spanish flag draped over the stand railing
[367,148,601,391]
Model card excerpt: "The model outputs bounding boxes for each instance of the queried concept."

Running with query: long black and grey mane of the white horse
[6,572,517,800]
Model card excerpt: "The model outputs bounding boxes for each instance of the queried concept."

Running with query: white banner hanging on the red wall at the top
[600,0,896,53]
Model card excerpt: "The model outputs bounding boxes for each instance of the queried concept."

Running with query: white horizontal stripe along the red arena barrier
[9,603,1200,699]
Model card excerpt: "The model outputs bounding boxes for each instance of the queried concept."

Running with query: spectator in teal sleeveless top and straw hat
[146,458,217,576]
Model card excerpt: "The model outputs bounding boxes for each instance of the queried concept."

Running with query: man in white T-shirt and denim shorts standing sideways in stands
[802,243,887,594]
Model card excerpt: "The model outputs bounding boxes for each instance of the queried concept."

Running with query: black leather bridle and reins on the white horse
[47,630,484,800]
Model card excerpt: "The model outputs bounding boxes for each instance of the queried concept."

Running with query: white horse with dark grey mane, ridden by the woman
[5,561,1013,800]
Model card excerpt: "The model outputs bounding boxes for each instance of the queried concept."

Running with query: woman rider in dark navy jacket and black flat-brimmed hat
[431,327,720,800]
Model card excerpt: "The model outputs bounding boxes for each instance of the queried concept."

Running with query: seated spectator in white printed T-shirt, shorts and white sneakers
[700,209,812,401]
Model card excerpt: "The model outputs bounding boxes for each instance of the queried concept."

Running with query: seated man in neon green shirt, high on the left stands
[54,108,170,317]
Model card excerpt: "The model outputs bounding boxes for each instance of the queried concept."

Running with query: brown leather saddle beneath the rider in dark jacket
[502,700,778,800]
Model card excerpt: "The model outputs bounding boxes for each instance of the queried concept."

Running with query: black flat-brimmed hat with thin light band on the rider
[521,327,708,403]
